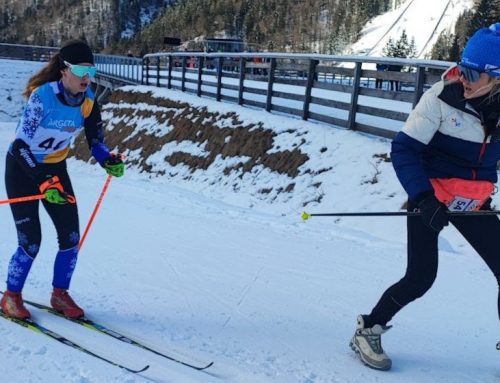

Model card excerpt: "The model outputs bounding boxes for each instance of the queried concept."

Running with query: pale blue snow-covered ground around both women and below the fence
[0,57,500,383]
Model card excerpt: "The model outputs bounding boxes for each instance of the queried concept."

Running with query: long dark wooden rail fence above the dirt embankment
[142,52,452,138]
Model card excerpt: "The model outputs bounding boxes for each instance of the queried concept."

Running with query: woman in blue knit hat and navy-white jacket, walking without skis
[350,23,500,370]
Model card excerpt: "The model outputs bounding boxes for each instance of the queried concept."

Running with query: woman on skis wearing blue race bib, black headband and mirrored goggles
[0,40,124,319]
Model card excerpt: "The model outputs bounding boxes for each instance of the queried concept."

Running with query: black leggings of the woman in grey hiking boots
[365,202,500,327]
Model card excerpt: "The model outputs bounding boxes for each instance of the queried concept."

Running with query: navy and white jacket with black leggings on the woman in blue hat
[363,81,500,327]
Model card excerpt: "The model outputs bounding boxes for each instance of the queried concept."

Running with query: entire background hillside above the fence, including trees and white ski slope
[0,0,488,60]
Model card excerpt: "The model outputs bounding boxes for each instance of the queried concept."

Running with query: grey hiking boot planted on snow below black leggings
[349,315,392,371]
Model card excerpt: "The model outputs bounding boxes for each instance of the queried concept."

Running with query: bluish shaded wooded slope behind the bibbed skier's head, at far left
[0,0,173,49]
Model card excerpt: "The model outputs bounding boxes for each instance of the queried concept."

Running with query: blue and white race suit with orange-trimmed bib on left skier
[5,81,109,292]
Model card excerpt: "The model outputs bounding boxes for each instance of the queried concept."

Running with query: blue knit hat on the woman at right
[460,23,500,77]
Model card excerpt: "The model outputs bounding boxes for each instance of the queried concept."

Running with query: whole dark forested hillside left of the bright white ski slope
[0,0,403,53]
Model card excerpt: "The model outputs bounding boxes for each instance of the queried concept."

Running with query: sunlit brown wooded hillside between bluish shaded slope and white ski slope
[126,0,403,53]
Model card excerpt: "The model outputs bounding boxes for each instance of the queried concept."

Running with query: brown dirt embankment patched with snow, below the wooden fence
[74,91,309,181]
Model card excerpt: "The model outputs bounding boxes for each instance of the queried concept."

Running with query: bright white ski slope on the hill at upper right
[349,0,473,59]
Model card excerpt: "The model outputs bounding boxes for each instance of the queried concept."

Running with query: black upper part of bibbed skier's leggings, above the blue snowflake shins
[5,154,80,258]
